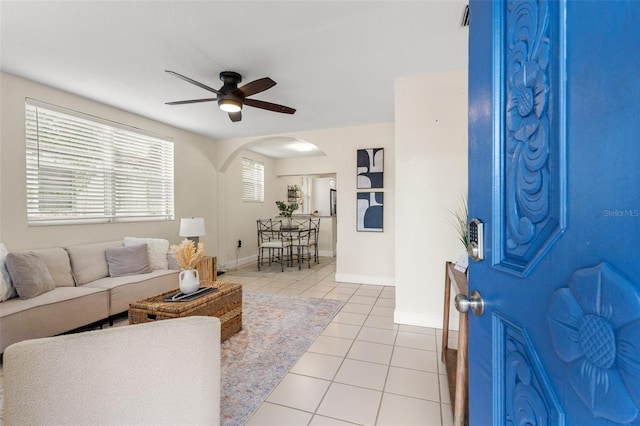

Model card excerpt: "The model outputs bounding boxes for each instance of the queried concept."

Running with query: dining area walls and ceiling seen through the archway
[217,136,337,272]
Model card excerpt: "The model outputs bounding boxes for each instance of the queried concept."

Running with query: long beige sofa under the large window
[0,241,179,353]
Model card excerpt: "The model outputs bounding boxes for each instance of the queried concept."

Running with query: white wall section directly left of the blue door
[392,71,467,328]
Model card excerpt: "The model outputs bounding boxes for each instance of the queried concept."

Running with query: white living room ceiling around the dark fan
[0,0,468,156]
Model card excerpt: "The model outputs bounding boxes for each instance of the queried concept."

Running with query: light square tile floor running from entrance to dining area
[219,258,457,426]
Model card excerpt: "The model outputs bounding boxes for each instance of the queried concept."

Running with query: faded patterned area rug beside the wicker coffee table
[220,292,344,426]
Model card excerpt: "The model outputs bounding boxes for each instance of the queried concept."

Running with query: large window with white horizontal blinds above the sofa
[25,99,174,225]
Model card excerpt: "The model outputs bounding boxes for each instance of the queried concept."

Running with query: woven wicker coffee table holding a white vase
[129,281,242,341]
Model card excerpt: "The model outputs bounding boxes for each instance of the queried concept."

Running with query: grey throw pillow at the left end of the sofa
[7,252,56,299]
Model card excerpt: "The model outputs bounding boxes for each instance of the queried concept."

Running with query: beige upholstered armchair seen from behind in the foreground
[3,317,220,426]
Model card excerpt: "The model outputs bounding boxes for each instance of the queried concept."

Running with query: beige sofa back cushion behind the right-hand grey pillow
[65,241,122,285]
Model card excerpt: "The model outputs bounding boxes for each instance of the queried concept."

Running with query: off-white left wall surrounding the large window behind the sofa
[0,73,217,255]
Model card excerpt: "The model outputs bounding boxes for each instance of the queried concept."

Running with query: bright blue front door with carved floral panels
[469,0,640,425]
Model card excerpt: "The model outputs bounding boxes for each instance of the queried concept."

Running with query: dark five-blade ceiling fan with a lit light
[165,70,296,122]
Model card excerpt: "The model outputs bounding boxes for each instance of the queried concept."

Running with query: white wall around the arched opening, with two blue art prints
[217,123,396,285]
